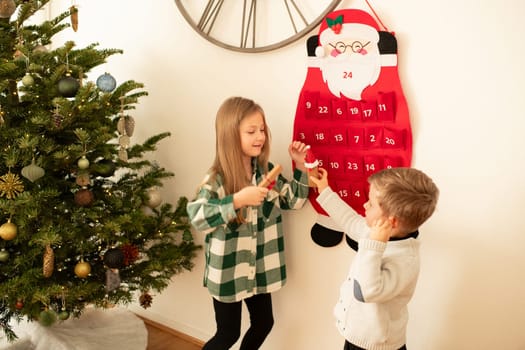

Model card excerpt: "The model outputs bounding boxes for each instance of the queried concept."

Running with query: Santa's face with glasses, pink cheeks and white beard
[319,38,381,100]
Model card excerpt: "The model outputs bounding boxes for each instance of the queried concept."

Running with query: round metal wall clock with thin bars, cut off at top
[175,0,342,53]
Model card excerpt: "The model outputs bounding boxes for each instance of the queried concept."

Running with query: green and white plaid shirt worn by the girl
[187,164,308,302]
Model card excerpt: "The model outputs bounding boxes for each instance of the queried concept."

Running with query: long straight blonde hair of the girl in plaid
[211,97,270,195]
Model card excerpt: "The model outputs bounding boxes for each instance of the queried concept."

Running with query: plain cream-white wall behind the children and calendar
[49,0,525,350]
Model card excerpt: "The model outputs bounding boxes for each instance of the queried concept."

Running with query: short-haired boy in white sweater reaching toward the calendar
[310,168,439,350]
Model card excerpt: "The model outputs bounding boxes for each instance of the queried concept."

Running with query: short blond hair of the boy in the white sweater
[368,168,439,233]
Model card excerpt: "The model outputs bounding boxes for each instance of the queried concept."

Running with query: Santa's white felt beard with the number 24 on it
[320,52,381,101]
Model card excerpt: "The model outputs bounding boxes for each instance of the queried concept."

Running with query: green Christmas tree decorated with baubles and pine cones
[0,0,200,340]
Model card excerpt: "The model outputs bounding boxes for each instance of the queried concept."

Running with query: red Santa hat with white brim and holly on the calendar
[316,9,379,56]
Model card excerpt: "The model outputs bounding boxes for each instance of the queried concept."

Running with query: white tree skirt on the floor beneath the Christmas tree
[0,307,148,350]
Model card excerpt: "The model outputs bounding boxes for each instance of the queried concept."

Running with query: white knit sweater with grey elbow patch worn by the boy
[317,188,420,350]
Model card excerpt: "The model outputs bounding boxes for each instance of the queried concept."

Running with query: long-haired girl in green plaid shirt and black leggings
[187,97,308,350]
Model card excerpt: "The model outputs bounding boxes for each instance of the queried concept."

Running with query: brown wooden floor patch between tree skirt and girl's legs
[142,318,204,350]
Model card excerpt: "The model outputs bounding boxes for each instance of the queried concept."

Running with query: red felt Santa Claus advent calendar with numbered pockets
[294,9,412,249]
